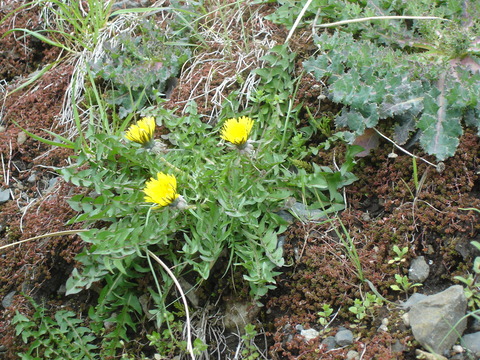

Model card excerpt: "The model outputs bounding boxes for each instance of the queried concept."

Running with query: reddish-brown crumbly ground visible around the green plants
[0,1,480,360]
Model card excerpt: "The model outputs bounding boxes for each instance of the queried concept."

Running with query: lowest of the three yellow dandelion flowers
[143,172,180,207]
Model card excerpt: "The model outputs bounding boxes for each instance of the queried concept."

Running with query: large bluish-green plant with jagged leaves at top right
[272,0,480,160]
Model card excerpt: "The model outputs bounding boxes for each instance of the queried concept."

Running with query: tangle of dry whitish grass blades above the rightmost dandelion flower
[174,2,276,122]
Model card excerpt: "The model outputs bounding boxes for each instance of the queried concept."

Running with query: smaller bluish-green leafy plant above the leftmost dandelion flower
[92,19,191,118]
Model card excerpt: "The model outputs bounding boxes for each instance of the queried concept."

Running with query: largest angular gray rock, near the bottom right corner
[408,285,467,355]
